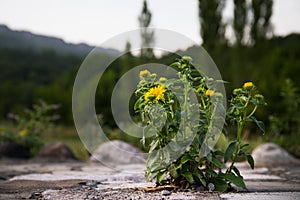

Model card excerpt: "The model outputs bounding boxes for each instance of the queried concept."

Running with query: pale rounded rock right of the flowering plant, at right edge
[252,143,299,166]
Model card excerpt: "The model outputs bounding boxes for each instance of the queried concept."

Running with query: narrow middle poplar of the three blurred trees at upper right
[233,0,247,46]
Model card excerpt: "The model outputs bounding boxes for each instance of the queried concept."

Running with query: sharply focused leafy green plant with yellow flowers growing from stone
[134,56,264,191]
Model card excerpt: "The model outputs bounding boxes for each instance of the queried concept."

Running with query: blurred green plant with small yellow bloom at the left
[0,101,58,155]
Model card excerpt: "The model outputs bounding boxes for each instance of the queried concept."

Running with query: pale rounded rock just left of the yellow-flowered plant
[90,140,146,165]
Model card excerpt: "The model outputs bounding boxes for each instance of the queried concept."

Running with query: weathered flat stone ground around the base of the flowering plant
[0,160,300,200]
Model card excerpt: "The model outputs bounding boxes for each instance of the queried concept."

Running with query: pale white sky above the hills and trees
[0,0,300,50]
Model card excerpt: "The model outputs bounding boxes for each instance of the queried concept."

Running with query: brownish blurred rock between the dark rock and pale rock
[34,142,77,162]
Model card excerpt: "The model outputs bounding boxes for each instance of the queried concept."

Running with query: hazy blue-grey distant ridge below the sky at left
[0,25,118,56]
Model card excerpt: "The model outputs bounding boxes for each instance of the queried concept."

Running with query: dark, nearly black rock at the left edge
[0,142,30,159]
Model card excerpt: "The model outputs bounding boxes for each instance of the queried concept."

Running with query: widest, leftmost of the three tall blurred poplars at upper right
[199,0,225,50]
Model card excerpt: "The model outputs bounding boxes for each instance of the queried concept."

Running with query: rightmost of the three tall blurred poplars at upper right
[250,0,273,44]
